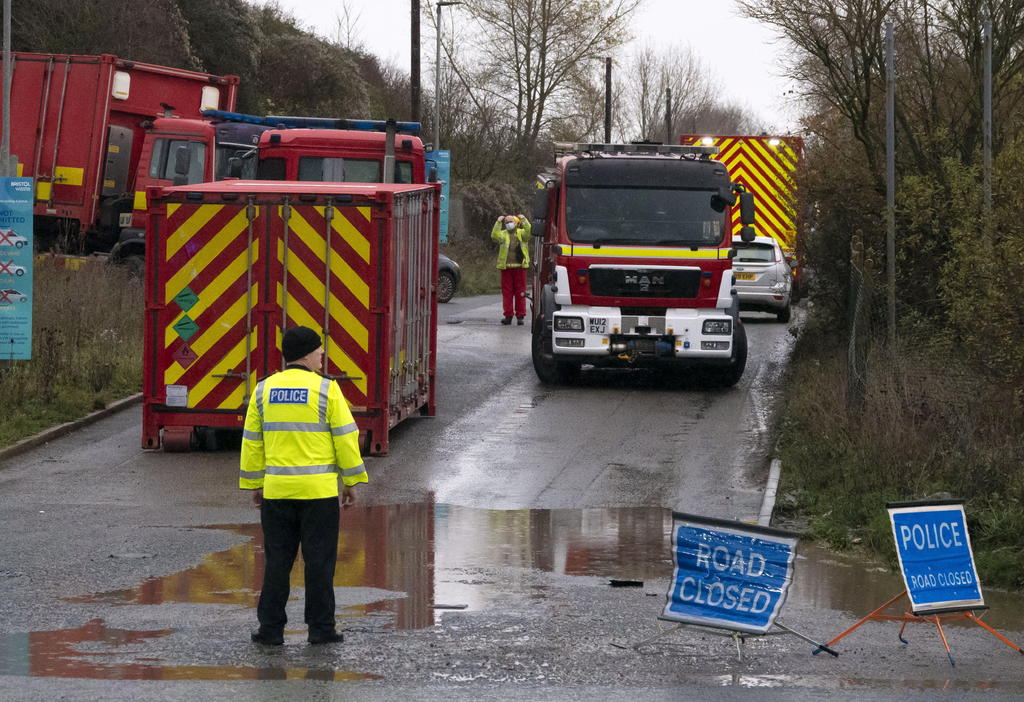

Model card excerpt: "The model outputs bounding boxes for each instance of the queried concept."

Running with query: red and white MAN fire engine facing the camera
[532,143,755,386]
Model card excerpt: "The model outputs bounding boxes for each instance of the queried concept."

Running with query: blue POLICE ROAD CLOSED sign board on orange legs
[888,501,985,614]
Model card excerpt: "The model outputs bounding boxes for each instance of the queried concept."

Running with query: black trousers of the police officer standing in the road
[256,497,339,632]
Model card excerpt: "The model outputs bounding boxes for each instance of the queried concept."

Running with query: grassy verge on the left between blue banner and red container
[0,262,142,447]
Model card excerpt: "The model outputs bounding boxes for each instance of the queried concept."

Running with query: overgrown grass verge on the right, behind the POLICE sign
[776,321,1024,588]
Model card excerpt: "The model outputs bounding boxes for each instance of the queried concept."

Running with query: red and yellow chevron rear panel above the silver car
[679,134,804,252]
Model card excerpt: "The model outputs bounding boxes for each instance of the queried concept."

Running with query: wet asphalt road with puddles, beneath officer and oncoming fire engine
[0,297,1024,700]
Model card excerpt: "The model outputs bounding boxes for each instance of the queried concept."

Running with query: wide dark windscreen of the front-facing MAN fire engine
[565,185,725,246]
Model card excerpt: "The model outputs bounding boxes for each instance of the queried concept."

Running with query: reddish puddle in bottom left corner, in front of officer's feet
[0,619,373,682]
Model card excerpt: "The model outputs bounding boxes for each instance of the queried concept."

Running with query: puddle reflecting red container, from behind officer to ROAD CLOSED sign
[70,502,672,629]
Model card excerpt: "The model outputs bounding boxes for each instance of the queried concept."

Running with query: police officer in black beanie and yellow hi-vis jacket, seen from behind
[239,326,368,646]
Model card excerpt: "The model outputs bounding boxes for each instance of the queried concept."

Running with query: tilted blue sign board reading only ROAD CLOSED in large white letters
[660,513,798,633]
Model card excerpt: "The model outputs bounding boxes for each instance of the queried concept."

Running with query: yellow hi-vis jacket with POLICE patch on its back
[239,367,369,499]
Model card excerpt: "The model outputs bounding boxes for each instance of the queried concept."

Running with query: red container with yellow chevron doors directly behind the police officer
[142,181,440,454]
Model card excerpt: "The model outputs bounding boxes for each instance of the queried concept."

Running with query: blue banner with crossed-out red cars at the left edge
[0,178,33,360]
